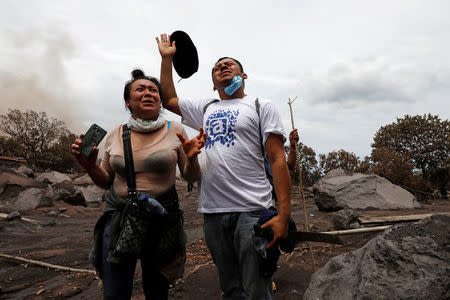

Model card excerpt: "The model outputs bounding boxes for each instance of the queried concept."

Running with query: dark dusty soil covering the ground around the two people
[0,182,450,299]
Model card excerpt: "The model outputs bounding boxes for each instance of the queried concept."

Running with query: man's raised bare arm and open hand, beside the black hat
[156,34,181,116]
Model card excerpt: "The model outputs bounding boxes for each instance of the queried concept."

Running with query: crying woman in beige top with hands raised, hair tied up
[72,70,206,299]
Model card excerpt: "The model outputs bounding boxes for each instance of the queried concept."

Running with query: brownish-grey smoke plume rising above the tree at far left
[0,29,80,132]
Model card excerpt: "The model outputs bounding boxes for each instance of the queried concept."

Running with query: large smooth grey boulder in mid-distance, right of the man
[313,170,420,211]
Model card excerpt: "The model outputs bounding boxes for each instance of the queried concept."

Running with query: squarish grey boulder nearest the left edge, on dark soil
[14,188,53,212]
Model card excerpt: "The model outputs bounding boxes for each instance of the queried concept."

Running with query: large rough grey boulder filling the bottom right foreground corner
[303,214,450,300]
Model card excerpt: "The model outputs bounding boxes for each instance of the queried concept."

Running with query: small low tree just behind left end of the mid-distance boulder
[319,149,359,174]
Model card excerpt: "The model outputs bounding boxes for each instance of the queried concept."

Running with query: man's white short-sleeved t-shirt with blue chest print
[179,96,286,213]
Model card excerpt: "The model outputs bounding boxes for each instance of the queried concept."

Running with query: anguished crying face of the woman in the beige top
[127,79,161,120]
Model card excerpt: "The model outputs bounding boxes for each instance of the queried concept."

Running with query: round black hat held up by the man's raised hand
[170,30,198,78]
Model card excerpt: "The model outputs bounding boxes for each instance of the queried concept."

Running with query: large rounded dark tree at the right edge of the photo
[372,114,450,179]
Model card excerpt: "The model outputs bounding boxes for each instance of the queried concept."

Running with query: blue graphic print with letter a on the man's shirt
[205,109,239,149]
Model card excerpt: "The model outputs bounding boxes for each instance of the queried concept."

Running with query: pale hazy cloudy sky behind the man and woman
[0,0,450,158]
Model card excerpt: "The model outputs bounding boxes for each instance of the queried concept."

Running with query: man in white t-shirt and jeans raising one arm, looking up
[156,34,290,299]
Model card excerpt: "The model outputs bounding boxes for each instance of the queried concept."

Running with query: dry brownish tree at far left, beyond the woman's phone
[0,109,73,168]
